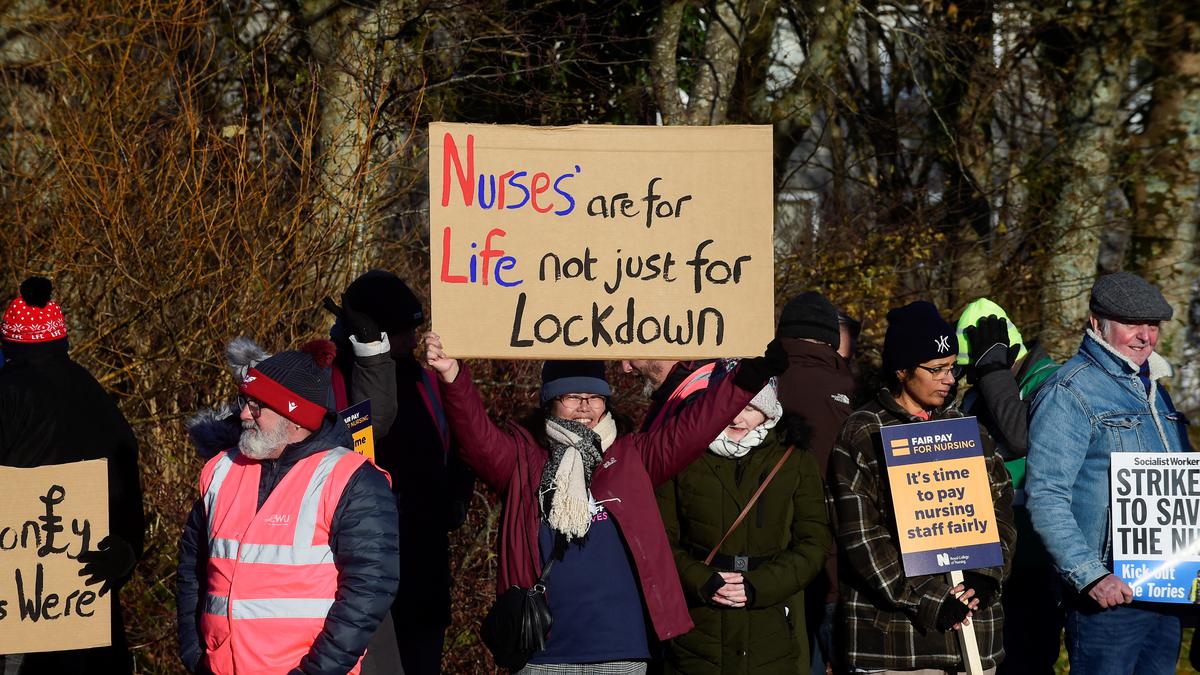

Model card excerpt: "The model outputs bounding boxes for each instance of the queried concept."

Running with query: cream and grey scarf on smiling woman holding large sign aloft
[538,413,617,542]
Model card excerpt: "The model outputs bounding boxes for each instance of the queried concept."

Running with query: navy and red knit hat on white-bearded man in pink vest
[238,352,329,431]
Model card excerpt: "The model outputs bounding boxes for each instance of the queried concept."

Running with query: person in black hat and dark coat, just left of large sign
[332,270,475,675]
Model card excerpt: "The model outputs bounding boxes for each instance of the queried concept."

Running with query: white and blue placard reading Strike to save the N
[1110,453,1200,604]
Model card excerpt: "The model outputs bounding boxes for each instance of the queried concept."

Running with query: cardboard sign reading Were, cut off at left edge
[0,459,112,653]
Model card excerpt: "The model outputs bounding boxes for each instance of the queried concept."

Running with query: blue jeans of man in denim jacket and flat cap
[1067,604,1181,675]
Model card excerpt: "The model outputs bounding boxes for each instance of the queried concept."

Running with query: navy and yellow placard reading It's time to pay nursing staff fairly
[880,417,1004,577]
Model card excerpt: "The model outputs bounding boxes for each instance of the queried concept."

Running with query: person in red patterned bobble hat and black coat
[0,276,145,674]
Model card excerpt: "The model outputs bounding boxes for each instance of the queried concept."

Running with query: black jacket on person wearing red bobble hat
[0,340,145,673]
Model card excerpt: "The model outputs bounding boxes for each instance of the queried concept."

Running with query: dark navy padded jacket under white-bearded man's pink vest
[175,414,400,675]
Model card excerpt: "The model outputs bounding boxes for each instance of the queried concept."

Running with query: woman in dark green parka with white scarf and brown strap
[658,369,833,675]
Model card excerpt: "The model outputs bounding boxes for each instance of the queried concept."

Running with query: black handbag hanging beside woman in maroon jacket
[479,534,565,673]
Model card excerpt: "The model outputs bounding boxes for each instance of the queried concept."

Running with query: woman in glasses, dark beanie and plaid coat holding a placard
[829,301,1016,674]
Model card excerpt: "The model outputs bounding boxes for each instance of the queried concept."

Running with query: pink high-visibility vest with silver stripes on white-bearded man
[200,448,367,675]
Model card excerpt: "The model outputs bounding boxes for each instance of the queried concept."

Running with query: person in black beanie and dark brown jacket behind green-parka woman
[775,291,854,675]
